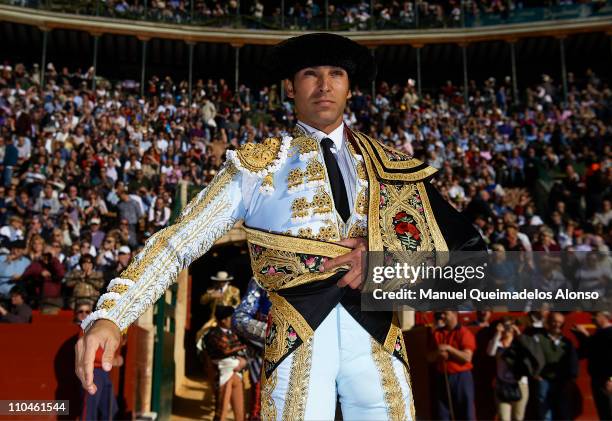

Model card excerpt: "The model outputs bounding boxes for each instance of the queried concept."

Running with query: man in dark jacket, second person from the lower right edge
[535,312,578,420]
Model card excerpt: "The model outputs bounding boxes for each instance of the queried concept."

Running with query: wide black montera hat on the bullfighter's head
[265,32,376,86]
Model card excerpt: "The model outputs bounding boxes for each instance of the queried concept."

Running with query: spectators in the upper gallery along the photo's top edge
[13,0,606,30]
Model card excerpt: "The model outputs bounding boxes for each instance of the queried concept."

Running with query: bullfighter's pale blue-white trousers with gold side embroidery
[262,304,415,421]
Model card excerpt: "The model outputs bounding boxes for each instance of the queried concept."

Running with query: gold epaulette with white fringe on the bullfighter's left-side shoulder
[227,137,291,194]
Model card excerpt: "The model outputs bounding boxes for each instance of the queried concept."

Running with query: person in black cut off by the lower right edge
[573,311,612,420]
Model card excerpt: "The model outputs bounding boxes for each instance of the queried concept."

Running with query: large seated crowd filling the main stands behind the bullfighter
[0,52,612,311]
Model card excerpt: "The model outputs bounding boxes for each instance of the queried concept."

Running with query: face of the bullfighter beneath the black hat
[285,66,351,130]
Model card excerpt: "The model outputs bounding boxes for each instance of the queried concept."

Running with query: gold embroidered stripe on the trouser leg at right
[370,338,406,421]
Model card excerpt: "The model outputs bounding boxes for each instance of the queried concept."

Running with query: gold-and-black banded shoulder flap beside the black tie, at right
[353,132,438,181]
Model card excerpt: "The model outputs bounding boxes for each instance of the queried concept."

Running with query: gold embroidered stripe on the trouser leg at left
[282,338,314,421]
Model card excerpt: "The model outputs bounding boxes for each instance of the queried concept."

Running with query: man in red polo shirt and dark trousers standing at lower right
[428,311,476,420]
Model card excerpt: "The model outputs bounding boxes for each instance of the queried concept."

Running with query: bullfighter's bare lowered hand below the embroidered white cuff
[75,319,121,395]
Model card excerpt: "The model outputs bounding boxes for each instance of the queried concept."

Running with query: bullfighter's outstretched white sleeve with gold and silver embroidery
[81,162,251,331]
